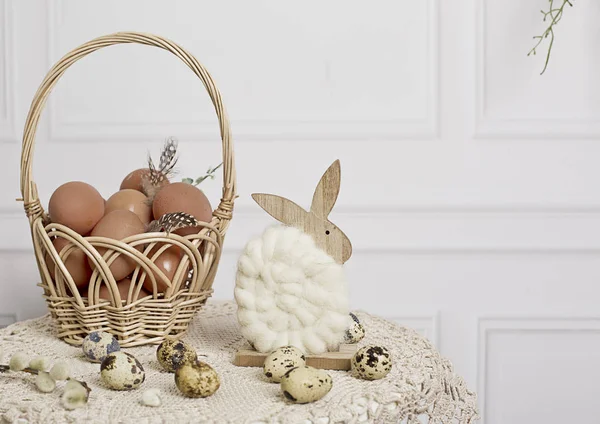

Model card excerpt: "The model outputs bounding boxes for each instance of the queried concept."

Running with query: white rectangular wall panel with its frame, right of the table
[479,316,600,424]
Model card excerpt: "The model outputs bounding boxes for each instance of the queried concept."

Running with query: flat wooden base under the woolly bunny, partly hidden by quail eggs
[233,344,357,371]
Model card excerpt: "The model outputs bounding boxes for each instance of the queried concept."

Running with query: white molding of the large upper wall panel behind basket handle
[47,0,440,143]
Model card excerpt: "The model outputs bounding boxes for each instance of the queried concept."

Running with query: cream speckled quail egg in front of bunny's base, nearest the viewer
[281,365,333,403]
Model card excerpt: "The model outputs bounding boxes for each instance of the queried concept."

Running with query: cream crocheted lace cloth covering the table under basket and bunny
[0,301,478,424]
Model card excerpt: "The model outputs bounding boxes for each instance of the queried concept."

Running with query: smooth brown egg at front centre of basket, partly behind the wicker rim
[90,210,145,280]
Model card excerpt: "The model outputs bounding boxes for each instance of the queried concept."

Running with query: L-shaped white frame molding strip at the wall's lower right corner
[477,315,600,422]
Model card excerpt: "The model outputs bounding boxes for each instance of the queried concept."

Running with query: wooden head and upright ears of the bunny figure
[252,160,352,264]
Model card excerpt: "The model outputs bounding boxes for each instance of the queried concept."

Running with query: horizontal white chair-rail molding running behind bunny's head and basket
[5,203,600,255]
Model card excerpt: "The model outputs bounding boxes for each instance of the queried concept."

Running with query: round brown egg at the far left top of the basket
[48,181,104,235]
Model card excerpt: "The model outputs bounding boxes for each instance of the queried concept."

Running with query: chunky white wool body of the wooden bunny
[235,225,349,354]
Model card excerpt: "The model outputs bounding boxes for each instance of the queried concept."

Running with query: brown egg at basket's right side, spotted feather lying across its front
[152,183,212,236]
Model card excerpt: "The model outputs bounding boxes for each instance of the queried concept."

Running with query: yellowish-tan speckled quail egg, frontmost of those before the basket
[175,361,221,397]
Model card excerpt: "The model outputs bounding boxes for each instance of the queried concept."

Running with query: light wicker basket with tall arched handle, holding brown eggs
[21,32,235,347]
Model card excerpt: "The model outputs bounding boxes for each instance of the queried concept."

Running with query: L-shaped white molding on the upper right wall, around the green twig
[473,0,600,140]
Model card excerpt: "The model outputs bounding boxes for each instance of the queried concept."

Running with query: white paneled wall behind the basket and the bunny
[0,0,600,424]
